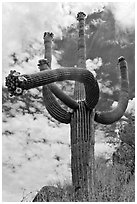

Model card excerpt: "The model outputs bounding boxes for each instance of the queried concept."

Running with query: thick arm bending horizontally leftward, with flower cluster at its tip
[6,68,99,108]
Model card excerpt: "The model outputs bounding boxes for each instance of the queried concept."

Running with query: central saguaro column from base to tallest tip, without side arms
[71,12,97,201]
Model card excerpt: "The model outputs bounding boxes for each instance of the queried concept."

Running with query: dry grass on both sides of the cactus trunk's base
[22,158,135,202]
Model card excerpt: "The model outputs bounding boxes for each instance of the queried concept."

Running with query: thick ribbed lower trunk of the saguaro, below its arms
[70,102,95,201]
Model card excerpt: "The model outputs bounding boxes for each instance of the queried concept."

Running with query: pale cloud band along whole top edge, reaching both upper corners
[2,2,134,79]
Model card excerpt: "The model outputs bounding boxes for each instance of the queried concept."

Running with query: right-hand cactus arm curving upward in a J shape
[95,57,129,124]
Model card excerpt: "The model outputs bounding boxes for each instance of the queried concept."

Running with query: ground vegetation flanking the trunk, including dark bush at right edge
[22,114,135,202]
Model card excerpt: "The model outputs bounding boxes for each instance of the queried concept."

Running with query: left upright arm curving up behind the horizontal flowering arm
[38,32,70,120]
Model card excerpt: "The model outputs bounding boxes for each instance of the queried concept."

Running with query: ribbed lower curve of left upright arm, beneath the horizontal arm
[42,86,71,124]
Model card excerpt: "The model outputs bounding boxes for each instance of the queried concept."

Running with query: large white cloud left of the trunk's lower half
[2,112,71,202]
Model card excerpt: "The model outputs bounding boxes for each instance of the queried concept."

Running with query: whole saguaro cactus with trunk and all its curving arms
[6,12,129,201]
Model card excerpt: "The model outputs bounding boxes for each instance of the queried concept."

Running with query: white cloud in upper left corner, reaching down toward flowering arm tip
[2,2,76,83]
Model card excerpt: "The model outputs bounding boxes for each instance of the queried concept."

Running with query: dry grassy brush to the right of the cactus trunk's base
[96,158,135,202]
